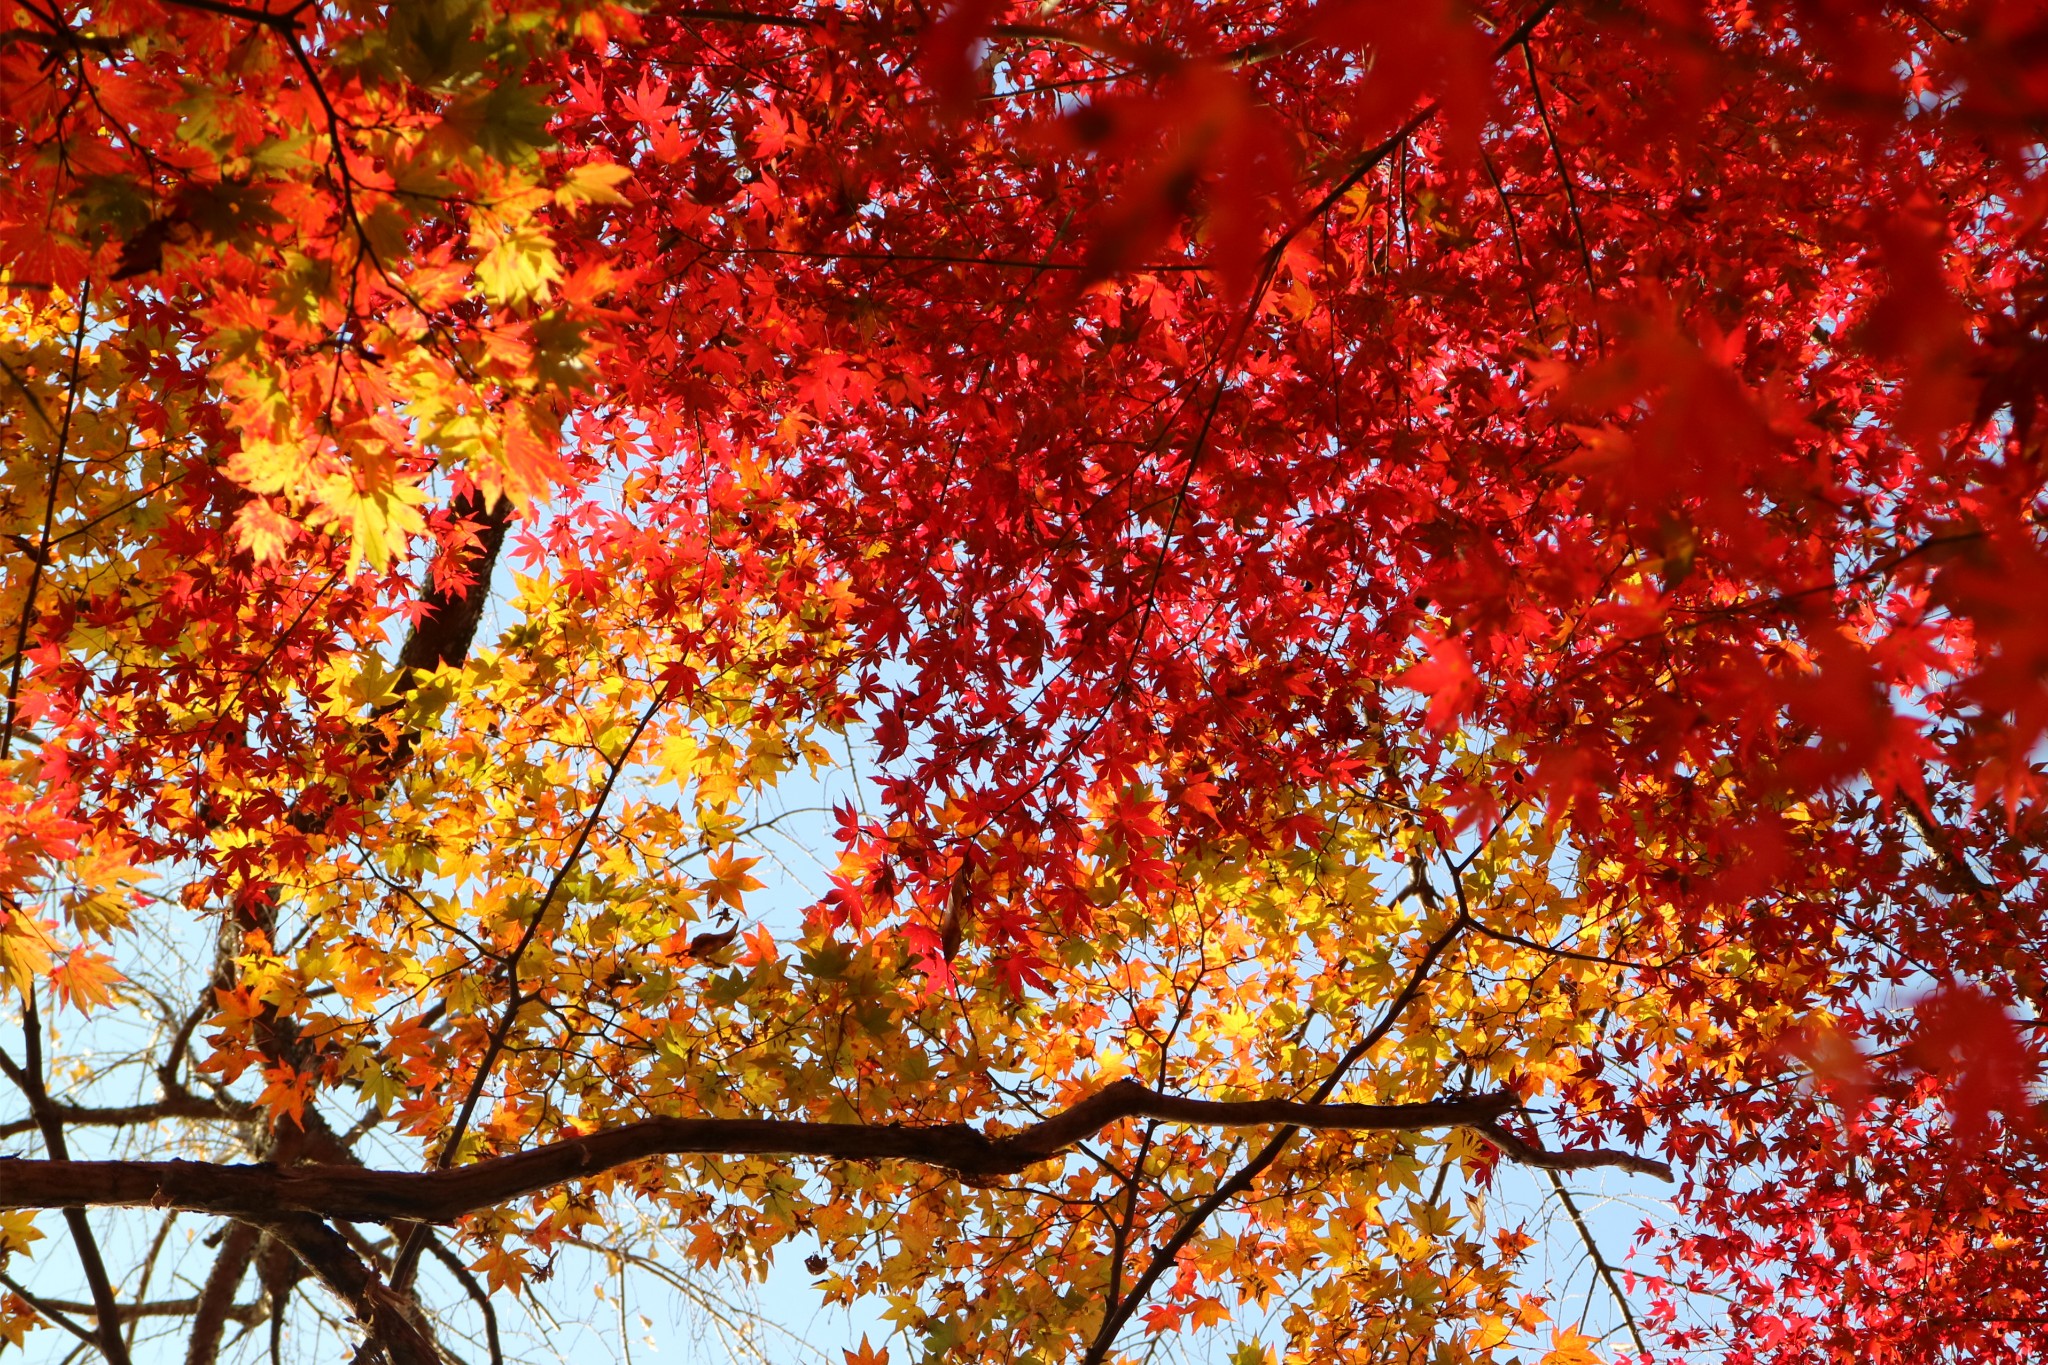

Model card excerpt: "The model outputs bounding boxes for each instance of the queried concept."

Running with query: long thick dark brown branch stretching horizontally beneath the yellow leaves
[0,1081,1663,1236]
